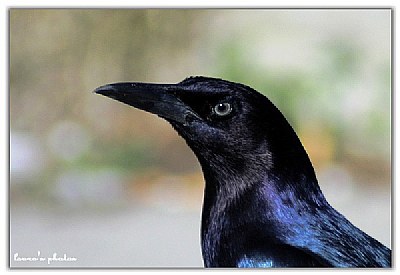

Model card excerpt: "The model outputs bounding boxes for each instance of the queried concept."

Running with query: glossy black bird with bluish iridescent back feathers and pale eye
[95,77,391,267]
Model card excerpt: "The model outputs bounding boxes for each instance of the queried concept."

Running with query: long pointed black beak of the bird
[94,83,198,125]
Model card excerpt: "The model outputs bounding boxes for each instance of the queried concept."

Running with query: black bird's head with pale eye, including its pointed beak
[95,77,313,184]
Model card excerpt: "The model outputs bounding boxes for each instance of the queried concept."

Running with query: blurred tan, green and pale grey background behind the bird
[9,9,391,267]
